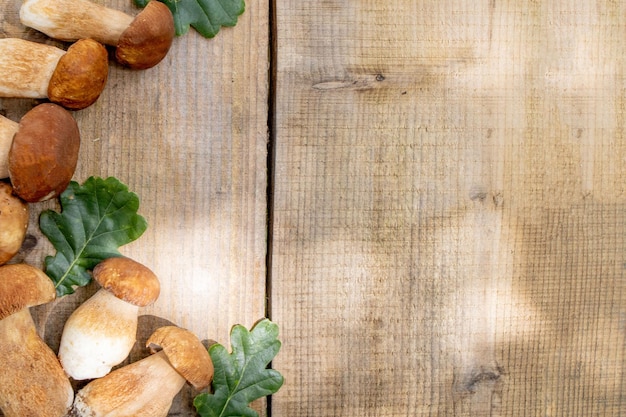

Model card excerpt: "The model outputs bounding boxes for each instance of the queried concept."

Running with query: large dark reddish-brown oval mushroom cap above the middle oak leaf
[9,103,80,203]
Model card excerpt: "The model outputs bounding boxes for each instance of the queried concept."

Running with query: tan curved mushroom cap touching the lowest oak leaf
[146,326,213,390]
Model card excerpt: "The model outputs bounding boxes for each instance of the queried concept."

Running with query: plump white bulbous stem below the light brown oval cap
[59,289,139,380]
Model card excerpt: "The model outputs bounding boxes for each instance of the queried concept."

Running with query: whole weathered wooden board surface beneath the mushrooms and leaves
[0,0,626,417]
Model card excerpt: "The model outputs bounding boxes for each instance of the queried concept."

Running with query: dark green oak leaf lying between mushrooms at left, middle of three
[39,177,147,297]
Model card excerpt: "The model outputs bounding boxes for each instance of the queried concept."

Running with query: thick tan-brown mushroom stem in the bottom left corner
[0,308,74,417]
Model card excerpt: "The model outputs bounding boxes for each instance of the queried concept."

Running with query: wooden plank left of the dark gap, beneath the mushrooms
[0,0,269,415]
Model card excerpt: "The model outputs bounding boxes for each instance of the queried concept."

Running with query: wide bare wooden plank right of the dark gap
[271,0,626,417]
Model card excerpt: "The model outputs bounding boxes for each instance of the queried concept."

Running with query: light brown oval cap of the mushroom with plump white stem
[93,257,161,307]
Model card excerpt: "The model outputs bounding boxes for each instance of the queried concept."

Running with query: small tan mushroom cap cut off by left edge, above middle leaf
[0,182,28,265]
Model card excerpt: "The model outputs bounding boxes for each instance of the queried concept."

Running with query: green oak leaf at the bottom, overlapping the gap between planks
[193,319,283,417]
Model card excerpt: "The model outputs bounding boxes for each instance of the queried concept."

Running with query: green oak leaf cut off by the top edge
[135,0,246,38]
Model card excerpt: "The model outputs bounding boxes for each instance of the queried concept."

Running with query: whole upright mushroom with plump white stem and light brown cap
[59,257,160,380]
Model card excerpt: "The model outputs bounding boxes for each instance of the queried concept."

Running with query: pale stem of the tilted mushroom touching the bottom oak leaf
[71,351,186,417]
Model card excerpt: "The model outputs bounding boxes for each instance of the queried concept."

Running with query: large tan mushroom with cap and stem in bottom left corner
[0,264,74,417]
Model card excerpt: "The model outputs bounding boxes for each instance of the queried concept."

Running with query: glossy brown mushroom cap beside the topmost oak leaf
[115,0,176,69]
